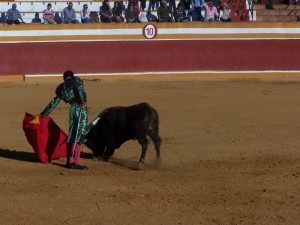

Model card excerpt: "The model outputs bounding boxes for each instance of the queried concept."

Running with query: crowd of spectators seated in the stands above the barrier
[4,0,231,24]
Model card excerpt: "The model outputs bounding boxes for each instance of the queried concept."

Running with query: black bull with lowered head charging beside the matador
[84,103,162,164]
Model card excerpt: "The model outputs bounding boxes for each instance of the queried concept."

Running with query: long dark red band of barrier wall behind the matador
[0,39,300,75]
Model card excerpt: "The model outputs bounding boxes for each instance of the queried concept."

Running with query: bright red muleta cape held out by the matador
[23,113,68,163]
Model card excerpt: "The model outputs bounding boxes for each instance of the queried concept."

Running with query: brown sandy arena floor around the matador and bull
[0,79,300,225]
